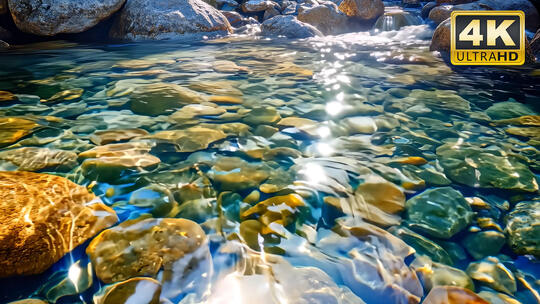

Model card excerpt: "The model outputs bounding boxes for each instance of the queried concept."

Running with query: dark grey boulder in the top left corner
[7,0,125,36]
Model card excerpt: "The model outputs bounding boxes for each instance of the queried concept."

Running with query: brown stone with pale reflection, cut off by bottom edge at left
[94,277,161,304]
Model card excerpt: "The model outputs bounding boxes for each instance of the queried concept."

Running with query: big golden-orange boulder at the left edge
[0,172,118,277]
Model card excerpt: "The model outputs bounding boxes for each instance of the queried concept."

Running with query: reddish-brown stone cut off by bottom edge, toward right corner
[422,286,489,304]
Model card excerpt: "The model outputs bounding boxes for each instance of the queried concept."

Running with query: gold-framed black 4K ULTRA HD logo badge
[450,11,525,65]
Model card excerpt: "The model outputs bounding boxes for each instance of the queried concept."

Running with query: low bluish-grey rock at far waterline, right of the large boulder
[261,15,323,38]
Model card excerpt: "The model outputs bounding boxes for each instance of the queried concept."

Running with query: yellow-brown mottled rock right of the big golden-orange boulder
[86,218,206,283]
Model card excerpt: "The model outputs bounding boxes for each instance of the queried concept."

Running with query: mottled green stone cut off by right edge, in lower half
[505,201,540,257]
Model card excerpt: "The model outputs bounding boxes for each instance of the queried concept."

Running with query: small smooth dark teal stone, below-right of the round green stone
[463,230,506,260]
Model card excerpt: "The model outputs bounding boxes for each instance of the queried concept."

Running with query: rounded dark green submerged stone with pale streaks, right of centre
[405,187,473,239]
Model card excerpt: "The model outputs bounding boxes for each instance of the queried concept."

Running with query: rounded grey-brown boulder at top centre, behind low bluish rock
[298,1,347,35]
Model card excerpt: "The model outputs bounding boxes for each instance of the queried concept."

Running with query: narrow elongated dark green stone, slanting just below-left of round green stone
[388,226,453,265]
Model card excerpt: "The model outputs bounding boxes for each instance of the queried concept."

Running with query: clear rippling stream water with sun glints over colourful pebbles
[0,10,540,303]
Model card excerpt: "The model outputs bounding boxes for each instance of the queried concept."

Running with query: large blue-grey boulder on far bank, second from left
[110,0,232,40]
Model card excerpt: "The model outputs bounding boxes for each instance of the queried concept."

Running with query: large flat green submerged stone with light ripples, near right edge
[437,142,538,192]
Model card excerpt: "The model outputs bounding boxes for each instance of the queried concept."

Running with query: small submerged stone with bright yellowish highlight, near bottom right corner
[467,257,517,294]
